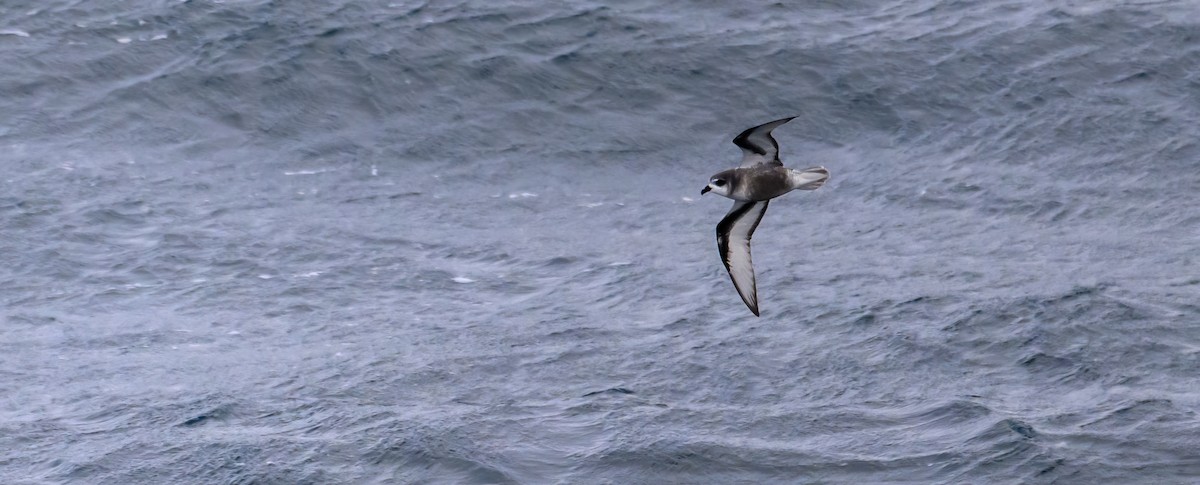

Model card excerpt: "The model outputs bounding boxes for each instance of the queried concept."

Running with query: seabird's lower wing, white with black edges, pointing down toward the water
[716,200,770,317]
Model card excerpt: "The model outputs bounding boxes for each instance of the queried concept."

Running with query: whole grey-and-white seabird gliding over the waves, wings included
[700,116,829,316]
